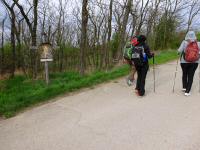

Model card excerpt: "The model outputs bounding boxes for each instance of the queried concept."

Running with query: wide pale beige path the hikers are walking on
[0,62,200,150]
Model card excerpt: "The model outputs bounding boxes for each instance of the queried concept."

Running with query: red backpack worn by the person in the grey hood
[185,42,199,62]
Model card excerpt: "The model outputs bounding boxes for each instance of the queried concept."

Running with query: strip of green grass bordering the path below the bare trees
[0,51,177,118]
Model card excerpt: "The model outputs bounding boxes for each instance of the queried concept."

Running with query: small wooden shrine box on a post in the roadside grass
[39,43,53,85]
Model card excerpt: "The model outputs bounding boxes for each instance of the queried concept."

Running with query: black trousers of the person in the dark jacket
[136,64,149,96]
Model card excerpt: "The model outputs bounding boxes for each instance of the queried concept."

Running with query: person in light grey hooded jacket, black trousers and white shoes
[178,31,200,96]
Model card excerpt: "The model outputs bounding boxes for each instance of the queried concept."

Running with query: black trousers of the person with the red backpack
[181,63,198,93]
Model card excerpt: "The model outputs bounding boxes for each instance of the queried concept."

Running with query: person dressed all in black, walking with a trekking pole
[135,35,154,96]
